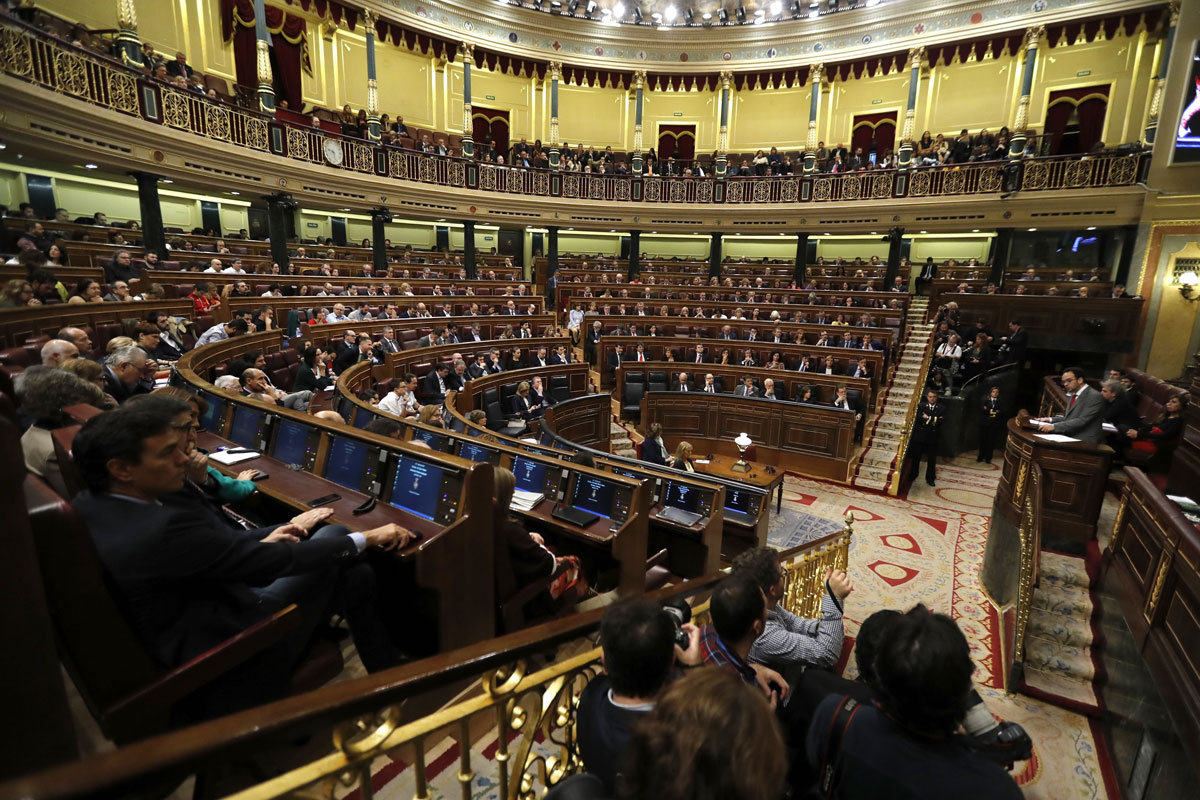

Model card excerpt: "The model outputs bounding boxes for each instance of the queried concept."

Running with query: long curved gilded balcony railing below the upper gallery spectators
[0,18,1148,205]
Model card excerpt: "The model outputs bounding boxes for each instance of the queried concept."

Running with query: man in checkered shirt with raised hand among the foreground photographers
[733,547,854,676]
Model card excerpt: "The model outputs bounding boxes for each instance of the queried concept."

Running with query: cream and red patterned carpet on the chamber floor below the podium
[787,455,1120,800]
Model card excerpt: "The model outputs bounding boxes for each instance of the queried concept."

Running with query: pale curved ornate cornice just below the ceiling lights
[365,0,1165,72]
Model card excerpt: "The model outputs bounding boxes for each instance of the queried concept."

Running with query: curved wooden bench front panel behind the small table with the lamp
[642,392,854,483]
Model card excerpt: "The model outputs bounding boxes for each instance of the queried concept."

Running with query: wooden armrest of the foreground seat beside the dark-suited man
[108,603,301,728]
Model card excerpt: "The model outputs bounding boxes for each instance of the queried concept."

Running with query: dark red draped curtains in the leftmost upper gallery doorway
[221,0,308,110]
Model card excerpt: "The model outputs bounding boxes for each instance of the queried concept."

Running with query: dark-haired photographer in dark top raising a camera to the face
[576,597,701,798]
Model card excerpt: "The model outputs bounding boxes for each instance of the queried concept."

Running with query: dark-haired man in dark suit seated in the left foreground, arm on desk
[73,398,412,711]
